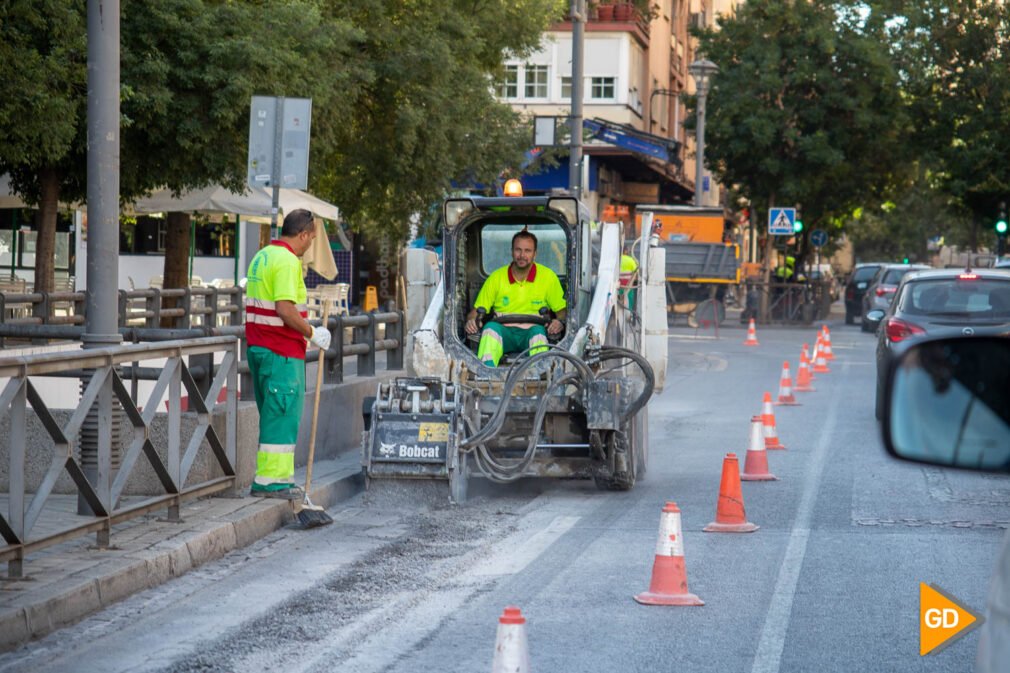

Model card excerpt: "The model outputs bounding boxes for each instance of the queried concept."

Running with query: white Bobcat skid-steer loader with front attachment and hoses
[362,185,667,503]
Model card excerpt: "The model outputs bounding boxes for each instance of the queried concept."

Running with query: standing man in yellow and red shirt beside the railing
[245,209,330,500]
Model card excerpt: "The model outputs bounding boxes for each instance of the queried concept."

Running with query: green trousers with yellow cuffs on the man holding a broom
[248,346,305,491]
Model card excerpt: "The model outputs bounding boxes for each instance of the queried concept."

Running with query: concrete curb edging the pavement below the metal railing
[0,455,365,652]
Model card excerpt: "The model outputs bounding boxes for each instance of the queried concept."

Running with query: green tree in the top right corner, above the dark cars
[875,0,1010,250]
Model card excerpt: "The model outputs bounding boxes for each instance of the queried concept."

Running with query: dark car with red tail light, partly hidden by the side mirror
[874,269,1010,418]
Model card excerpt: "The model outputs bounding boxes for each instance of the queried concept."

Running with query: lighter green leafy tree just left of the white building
[314,0,568,241]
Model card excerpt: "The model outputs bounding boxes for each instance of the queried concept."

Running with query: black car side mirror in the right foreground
[883,337,1010,472]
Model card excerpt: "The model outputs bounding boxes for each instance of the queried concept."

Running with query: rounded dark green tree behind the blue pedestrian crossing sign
[699,0,907,309]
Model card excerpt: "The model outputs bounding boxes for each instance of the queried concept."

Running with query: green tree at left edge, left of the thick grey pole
[0,0,88,292]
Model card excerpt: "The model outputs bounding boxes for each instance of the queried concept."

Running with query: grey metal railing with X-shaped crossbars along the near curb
[0,335,239,578]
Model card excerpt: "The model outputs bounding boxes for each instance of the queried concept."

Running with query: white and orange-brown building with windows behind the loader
[498,0,736,213]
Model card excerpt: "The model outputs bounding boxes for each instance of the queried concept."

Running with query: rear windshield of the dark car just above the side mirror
[901,278,1010,318]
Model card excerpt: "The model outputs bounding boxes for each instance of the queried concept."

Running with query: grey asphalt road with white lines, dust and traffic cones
[0,325,1010,673]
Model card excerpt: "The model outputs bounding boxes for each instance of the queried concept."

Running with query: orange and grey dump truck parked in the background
[635,205,741,322]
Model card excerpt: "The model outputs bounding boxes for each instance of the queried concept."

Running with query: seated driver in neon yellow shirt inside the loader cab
[465,229,567,367]
